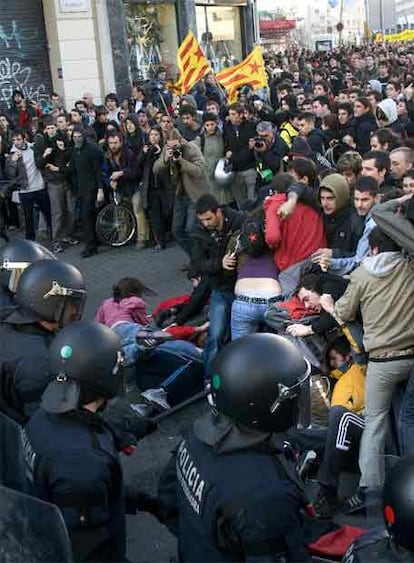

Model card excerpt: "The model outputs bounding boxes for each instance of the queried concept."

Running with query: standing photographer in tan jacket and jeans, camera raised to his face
[154,129,206,257]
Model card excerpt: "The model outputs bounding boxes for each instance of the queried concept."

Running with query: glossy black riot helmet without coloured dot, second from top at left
[16,260,86,326]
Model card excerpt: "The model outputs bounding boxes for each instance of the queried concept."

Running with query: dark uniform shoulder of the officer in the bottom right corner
[343,528,414,563]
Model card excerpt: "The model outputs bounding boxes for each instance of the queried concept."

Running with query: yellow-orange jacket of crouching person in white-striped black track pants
[331,364,366,413]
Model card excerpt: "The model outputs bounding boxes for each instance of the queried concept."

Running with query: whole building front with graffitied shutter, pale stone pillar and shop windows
[0,0,258,108]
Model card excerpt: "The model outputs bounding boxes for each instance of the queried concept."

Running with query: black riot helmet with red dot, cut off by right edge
[383,454,414,551]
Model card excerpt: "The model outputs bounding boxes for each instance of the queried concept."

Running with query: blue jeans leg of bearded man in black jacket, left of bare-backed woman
[204,291,234,377]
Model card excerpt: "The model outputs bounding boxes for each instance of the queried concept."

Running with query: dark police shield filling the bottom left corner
[0,486,72,563]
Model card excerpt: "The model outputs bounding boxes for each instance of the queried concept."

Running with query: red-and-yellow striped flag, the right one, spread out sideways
[216,46,267,102]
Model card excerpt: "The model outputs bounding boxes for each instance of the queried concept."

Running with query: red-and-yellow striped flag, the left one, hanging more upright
[174,31,211,94]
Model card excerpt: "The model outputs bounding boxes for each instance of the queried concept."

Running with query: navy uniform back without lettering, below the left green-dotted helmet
[24,408,126,562]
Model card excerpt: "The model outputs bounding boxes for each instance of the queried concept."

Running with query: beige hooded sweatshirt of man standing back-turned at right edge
[335,252,414,360]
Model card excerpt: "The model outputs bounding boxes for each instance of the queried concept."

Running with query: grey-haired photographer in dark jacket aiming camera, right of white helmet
[249,121,289,186]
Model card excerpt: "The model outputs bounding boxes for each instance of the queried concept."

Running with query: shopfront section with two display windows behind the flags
[123,0,258,80]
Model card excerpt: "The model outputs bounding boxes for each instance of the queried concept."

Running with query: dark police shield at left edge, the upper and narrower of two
[0,413,27,492]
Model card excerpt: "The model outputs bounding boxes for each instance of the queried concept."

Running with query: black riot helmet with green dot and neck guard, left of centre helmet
[41,321,122,413]
